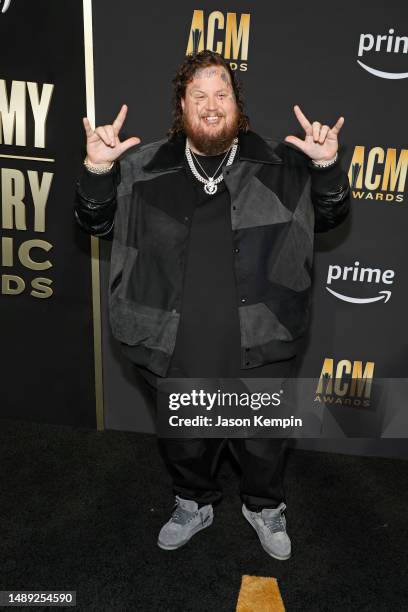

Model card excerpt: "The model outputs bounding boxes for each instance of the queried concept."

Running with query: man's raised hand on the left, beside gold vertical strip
[82,104,140,166]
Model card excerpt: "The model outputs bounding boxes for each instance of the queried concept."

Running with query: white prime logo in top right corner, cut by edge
[357,28,408,79]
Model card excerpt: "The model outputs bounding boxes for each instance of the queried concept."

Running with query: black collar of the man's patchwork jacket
[143,130,283,172]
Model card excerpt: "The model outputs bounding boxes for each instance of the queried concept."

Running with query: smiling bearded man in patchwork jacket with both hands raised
[75,51,349,559]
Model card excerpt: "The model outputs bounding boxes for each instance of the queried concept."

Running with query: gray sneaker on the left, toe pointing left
[157,495,214,550]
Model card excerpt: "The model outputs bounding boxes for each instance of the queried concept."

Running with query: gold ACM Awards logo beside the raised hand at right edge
[348,145,408,203]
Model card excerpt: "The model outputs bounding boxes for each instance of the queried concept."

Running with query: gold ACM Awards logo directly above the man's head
[186,10,251,72]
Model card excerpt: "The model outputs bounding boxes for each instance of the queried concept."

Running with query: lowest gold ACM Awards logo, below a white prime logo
[314,357,375,408]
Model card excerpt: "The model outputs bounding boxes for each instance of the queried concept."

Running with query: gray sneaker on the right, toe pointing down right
[242,502,291,560]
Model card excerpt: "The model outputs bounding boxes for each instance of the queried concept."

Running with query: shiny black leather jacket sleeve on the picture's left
[74,161,121,240]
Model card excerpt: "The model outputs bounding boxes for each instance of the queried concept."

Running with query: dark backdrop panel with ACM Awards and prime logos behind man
[93,0,408,456]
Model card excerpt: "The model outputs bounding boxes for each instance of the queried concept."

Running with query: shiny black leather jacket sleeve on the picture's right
[308,159,350,232]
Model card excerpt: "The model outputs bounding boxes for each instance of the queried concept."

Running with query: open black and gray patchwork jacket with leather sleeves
[74,131,350,376]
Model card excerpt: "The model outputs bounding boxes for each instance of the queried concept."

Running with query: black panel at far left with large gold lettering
[0,0,96,427]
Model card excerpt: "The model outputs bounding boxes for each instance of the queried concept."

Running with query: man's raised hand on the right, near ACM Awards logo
[285,104,344,162]
